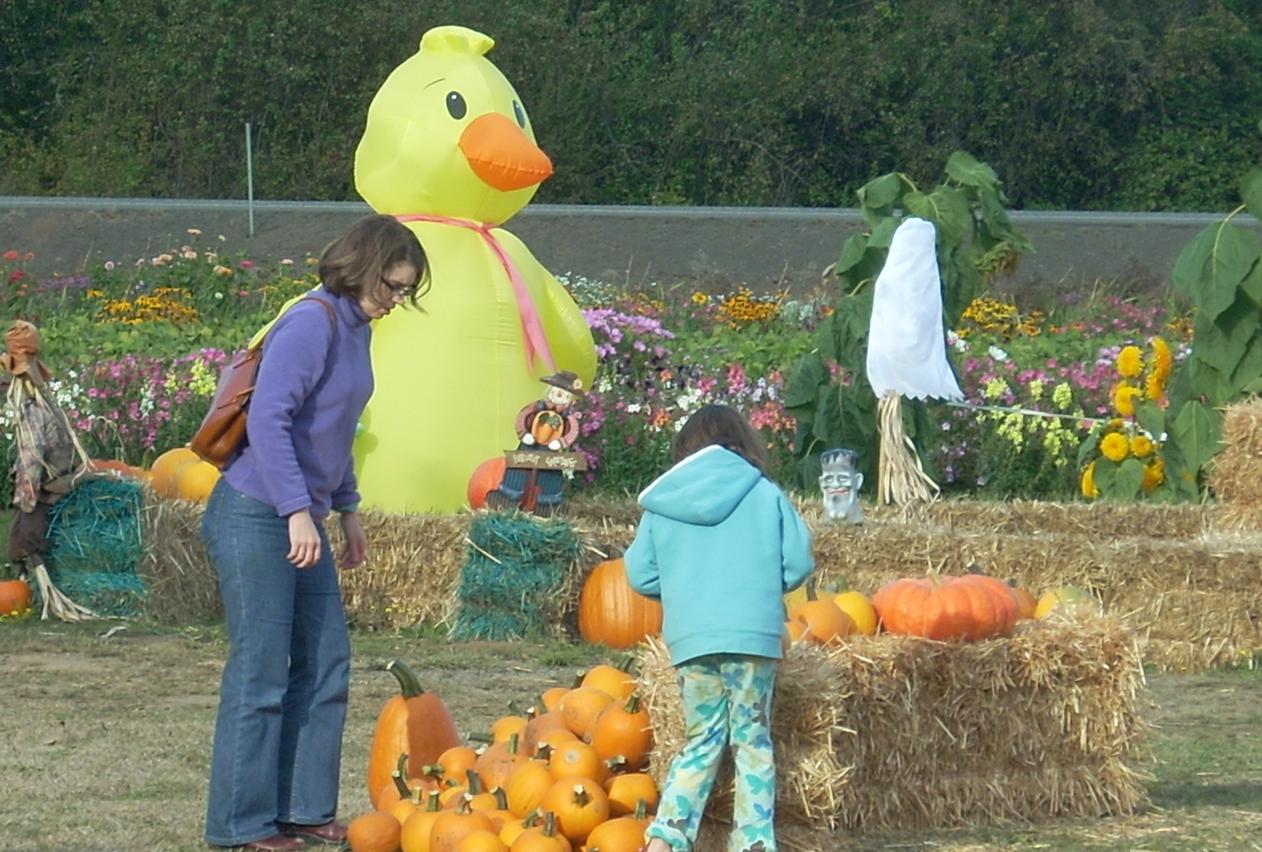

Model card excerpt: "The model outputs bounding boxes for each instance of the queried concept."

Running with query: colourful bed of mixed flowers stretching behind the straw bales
[0,236,1190,501]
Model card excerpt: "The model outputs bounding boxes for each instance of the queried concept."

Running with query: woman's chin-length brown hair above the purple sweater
[319,216,429,307]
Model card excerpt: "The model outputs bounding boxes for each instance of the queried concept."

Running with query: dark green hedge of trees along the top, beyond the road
[0,0,1262,211]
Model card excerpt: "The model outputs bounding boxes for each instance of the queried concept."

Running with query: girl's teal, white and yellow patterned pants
[645,654,779,852]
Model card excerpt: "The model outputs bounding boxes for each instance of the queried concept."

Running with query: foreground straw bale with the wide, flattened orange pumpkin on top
[640,618,1146,848]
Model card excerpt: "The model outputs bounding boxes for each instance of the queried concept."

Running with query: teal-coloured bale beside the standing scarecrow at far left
[44,477,145,616]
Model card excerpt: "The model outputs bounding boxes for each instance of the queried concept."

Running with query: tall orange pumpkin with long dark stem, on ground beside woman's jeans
[367,660,461,808]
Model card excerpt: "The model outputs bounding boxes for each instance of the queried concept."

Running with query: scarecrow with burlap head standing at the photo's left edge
[0,319,96,621]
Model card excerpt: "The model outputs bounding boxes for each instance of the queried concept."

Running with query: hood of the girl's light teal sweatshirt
[640,444,762,526]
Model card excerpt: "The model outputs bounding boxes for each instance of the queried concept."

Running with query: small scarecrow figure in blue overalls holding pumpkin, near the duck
[487,370,583,516]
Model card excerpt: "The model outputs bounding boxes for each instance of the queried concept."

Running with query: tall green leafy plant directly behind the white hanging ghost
[785,151,1032,488]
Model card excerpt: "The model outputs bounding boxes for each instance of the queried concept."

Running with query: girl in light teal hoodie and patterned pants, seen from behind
[626,405,814,852]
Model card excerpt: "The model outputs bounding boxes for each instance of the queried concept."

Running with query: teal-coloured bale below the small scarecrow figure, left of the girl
[452,512,582,640]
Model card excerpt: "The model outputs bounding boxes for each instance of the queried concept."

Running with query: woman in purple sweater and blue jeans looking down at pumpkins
[202,216,428,849]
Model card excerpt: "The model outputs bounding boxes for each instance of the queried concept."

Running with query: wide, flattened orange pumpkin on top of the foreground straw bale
[872,574,1017,640]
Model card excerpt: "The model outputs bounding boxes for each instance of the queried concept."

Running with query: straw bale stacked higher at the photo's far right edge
[1209,396,1262,530]
